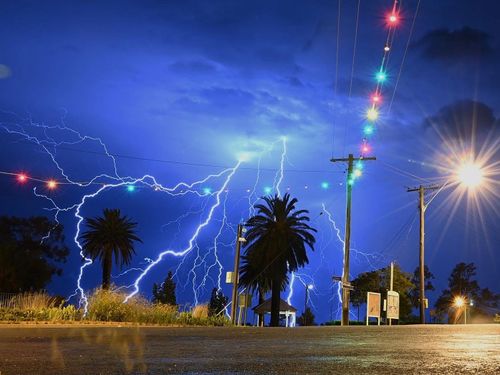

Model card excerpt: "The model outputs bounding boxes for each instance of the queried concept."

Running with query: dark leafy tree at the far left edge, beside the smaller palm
[0,216,69,293]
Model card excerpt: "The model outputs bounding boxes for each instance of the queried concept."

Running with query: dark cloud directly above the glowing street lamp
[424,100,498,139]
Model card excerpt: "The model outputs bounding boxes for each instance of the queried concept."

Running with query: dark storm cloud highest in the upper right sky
[414,27,493,62]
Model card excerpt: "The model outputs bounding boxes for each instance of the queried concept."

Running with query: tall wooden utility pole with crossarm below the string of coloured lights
[330,154,376,326]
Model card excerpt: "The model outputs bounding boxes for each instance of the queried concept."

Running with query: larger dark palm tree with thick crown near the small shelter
[240,194,316,327]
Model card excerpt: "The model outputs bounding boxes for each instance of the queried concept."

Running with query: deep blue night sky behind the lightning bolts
[0,0,500,322]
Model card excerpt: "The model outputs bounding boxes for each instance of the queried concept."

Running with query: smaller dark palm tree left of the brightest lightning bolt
[81,208,142,289]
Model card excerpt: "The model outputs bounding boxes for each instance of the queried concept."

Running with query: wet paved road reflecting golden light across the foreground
[0,325,500,375]
